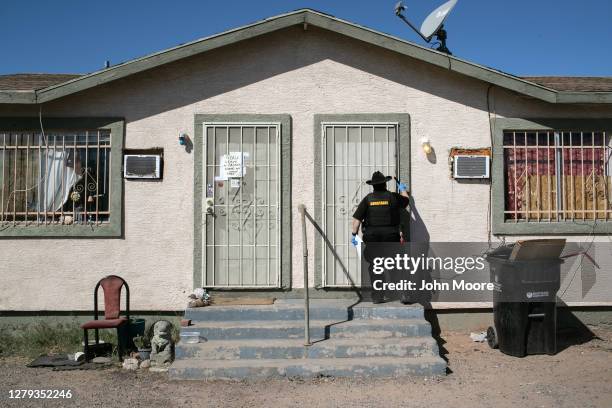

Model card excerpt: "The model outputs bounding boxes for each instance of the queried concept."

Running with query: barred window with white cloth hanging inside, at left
[0,129,112,227]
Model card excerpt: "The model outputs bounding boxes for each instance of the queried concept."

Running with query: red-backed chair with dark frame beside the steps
[81,275,130,359]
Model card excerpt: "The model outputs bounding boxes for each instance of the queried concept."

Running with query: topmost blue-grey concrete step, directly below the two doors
[185,299,423,322]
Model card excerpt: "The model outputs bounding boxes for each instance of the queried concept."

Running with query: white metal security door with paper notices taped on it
[202,123,281,288]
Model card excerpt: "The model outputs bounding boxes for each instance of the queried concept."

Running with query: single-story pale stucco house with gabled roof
[0,9,612,312]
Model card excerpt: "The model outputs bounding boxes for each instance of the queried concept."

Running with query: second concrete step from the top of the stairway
[181,319,431,341]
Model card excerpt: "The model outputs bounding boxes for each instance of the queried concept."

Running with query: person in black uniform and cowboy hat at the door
[351,171,410,303]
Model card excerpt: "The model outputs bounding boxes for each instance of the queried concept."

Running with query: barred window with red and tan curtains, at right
[503,130,612,222]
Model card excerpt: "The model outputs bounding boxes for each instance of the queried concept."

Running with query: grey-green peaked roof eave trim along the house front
[0,9,612,103]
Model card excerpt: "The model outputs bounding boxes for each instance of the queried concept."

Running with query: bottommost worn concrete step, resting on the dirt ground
[169,356,446,380]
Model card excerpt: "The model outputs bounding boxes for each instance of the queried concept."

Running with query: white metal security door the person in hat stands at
[321,123,398,287]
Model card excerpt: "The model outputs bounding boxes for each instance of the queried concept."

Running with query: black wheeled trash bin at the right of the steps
[487,246,563,357]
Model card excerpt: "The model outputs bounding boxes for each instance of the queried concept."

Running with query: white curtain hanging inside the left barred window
[37,149,81,211]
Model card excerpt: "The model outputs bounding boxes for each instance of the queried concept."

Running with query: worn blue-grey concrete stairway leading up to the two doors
[169,300,446,380]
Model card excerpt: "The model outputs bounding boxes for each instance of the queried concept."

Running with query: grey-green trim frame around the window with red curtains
[491,118,612,235]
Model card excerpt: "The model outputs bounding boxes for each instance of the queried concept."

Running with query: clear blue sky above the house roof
[0,0,612,76]
